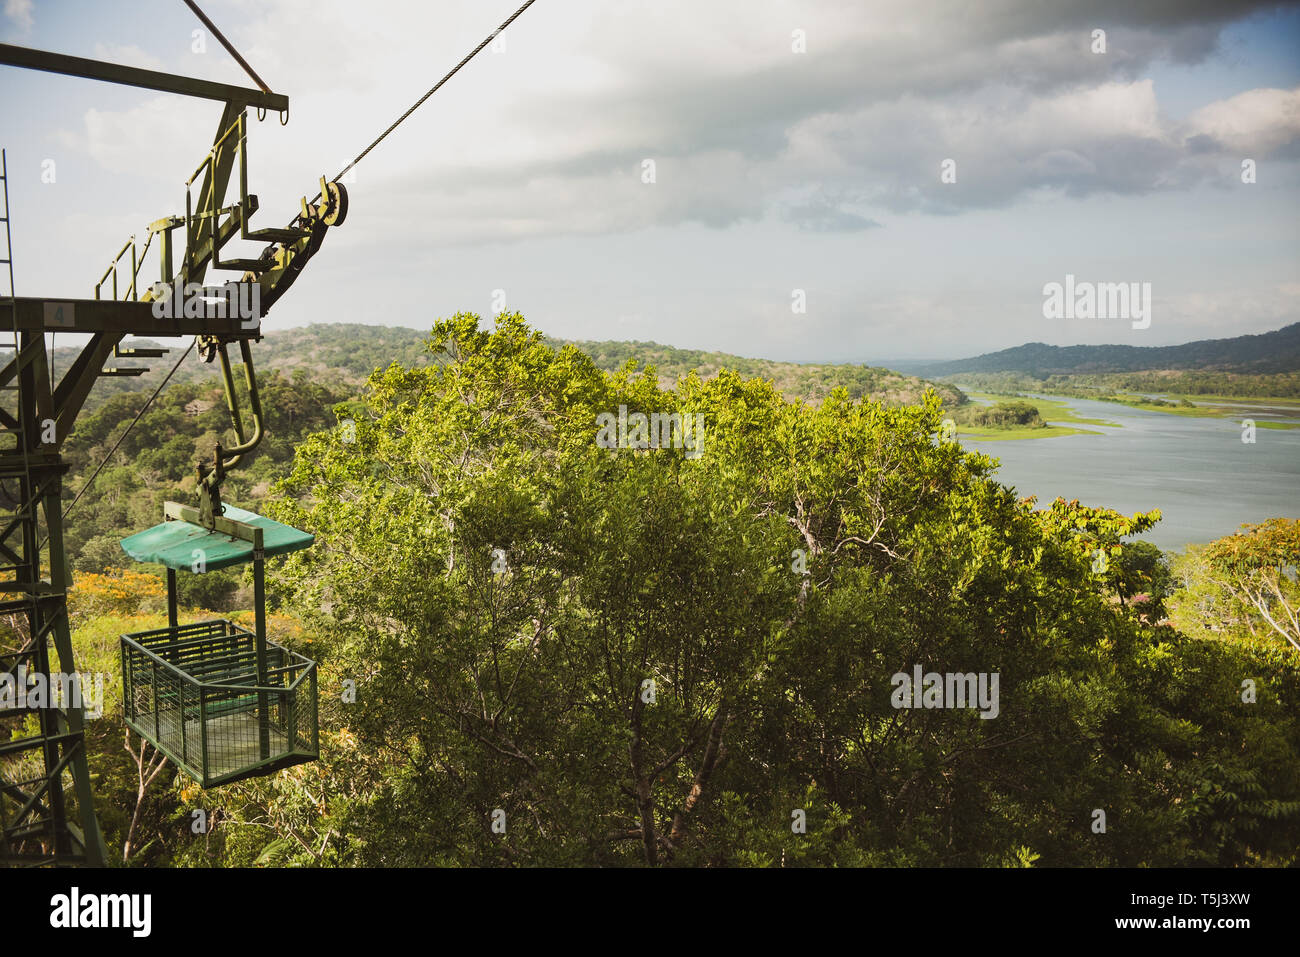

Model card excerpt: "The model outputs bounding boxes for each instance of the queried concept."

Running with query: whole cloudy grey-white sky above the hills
[0,0,1300,363]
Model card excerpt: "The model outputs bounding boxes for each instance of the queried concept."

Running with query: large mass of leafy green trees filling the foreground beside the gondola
[172,315,1300,866]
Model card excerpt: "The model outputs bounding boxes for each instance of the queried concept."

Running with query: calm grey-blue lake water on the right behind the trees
[962,395,1300,551]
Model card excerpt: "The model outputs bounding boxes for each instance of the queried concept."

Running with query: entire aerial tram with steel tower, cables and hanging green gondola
[0,0,536,866]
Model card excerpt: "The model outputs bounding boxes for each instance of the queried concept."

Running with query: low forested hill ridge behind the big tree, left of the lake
[78,322,965,408]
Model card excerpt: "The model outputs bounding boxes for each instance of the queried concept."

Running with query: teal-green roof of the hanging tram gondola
[122,505,316,571]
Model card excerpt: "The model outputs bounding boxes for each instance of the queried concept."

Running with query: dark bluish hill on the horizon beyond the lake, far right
[897,322,1300,378]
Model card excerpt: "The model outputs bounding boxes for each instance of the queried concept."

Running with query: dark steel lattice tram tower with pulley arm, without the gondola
[0,35,347,865]
